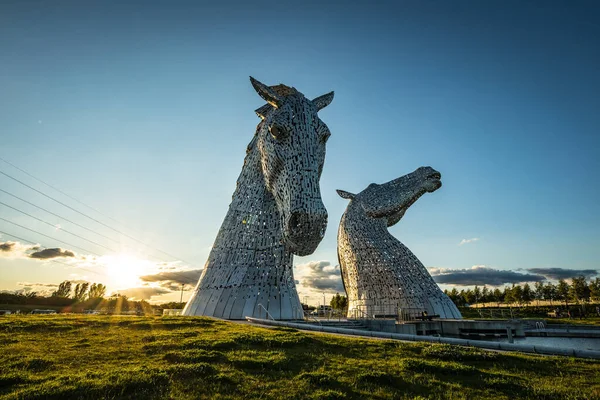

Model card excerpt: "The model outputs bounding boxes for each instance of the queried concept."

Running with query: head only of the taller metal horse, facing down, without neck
[250,77,333,256]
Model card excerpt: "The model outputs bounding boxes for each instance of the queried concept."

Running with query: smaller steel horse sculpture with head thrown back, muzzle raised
[338,167,461,318]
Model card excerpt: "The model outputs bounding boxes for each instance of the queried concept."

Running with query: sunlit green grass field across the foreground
[0,315,600,399]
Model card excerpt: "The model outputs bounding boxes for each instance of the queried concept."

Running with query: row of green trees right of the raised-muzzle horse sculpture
[444,276,600,307]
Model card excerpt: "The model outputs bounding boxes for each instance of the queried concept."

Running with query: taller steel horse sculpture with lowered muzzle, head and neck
[183,77,333,319]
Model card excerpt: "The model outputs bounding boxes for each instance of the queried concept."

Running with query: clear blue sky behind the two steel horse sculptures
[0,1,600,304]
